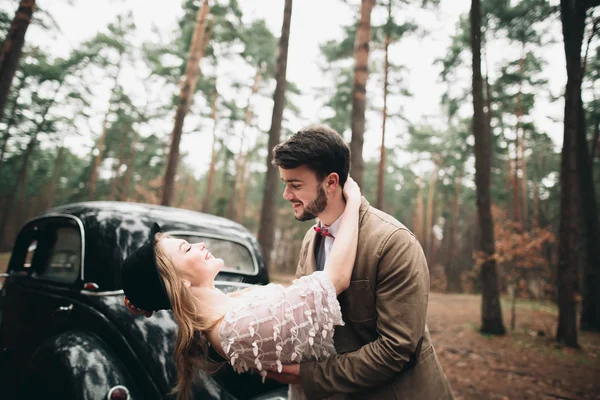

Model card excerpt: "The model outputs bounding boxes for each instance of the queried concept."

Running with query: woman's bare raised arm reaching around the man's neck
[324,177,361,295]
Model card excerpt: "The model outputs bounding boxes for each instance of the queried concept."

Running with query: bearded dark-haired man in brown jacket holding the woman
[269,125,453,400]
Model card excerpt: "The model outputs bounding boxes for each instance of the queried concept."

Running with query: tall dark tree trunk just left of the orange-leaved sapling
[470,0,505,334]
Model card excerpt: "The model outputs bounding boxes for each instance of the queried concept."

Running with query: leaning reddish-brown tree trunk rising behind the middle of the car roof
[160,0,210,206]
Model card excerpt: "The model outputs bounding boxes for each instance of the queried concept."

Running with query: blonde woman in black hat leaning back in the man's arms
[121,178,361,399]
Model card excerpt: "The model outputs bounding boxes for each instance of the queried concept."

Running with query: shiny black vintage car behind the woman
[0,202,287,400]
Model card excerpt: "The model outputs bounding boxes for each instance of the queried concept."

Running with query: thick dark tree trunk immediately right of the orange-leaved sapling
[556,0,586,347]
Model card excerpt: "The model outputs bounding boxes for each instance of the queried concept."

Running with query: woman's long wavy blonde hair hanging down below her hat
[154,233,222,400]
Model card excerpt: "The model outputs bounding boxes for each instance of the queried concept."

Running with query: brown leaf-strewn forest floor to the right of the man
[272,276,600,400]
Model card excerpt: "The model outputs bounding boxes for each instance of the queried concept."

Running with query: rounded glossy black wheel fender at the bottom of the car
[21,331,141,400]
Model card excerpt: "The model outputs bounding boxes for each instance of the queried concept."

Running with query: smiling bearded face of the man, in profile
[279,165,327,221]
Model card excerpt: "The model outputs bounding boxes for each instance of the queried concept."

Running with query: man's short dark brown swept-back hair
[273,125,350,187]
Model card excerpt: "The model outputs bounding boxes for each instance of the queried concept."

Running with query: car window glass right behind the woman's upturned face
[169,233,258,275]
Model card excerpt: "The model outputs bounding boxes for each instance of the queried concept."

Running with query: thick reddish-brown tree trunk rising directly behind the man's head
[350,0,374,187]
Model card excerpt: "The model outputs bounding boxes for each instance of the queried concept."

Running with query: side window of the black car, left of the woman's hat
[32,224,82,283]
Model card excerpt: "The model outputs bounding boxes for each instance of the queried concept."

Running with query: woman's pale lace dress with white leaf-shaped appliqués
[219,271,344,400]
